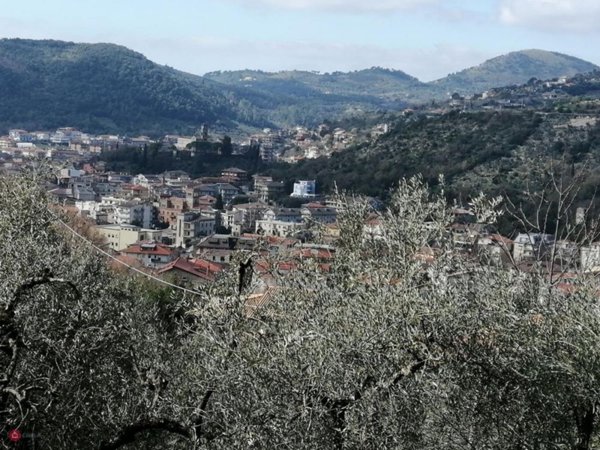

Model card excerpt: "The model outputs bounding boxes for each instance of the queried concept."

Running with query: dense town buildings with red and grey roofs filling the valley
[0,128,600,304]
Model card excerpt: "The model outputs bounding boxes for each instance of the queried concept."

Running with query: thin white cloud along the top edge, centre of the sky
[224,0,440,13]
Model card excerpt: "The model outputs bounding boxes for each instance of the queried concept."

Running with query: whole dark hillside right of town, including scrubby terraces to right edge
[270,111,600,199]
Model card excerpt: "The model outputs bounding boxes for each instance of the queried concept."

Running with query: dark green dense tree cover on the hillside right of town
[269,112,540,197]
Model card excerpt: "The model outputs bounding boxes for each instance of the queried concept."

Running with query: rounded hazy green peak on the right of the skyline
[429,50,599,94]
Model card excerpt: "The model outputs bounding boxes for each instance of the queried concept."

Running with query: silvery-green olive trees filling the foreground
[0,177,600,450]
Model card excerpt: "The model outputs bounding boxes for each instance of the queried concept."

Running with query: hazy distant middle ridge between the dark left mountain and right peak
[204,67,426,126]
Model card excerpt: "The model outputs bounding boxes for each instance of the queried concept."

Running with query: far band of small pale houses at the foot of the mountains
[0,123,389,170]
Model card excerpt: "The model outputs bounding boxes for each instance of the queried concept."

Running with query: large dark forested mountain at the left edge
[0,39,248,133]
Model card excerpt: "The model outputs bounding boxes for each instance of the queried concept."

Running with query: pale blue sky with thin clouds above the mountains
[0,0,600,81]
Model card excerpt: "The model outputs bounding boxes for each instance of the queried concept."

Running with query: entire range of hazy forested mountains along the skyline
[0,39,596,135]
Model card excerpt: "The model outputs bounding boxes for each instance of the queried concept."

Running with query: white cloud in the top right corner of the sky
[499,0,600,33]
